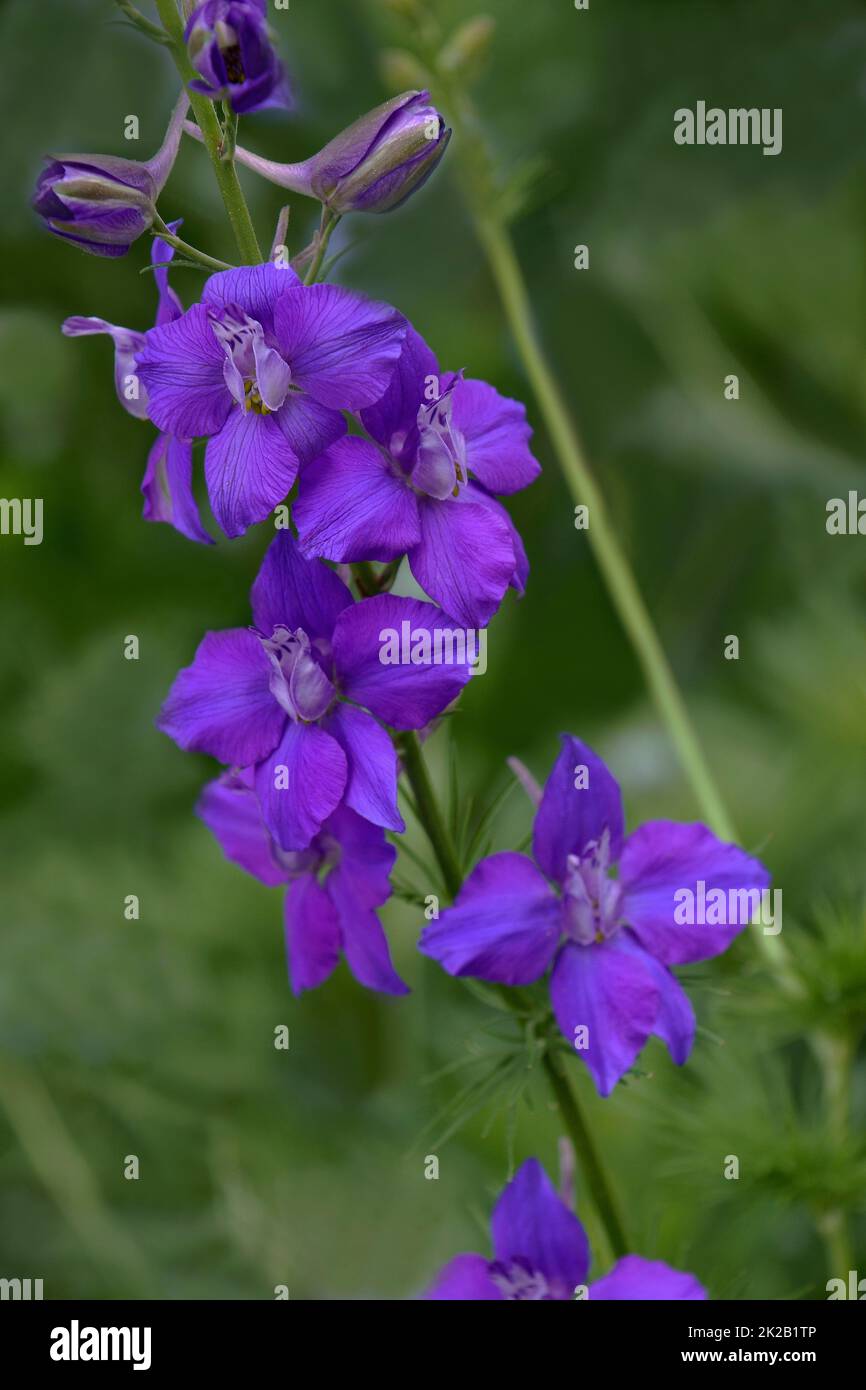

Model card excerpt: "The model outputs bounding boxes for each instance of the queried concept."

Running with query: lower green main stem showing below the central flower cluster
[399,733,628,1259]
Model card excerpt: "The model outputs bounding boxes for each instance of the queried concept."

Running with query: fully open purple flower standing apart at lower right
[420,734,770,1095]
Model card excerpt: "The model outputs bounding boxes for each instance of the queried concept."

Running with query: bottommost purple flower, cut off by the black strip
[425,1158,706,1302]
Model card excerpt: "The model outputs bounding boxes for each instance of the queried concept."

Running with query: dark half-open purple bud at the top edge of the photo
[183,0,292,115]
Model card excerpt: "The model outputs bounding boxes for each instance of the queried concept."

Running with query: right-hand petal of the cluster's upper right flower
[453,379,541,493]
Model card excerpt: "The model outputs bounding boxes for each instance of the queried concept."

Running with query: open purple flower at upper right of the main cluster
[295,328,541,628]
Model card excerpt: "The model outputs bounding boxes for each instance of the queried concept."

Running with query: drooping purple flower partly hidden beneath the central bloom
[196,769,409,994]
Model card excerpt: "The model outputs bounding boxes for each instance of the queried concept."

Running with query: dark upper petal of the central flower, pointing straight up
[250,531,353,642]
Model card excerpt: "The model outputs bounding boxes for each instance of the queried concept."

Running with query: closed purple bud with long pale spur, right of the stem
[195,92,452,217]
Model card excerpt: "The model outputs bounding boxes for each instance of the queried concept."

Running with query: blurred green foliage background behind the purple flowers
[0,0,866,1300]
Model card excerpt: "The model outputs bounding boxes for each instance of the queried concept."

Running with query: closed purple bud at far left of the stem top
[33,92,189,256]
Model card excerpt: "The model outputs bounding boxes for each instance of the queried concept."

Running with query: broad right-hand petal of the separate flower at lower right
[620,820,770,965]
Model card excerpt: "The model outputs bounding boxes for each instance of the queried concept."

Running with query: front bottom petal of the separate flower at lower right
[550,940,659,1095]
